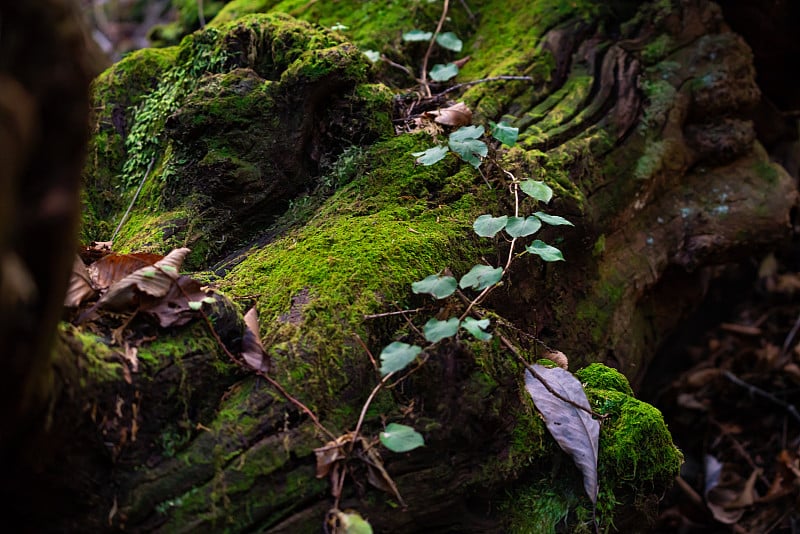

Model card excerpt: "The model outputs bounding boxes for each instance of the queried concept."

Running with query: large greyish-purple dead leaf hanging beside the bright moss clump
[525,364,600,503]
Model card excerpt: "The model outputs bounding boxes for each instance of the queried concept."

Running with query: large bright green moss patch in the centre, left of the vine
[216,136,488,414]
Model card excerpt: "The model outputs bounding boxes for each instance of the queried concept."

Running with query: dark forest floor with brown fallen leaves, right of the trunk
[641,248,800,534]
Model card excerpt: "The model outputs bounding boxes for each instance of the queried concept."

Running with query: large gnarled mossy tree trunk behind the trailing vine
[6,0,796,532]
